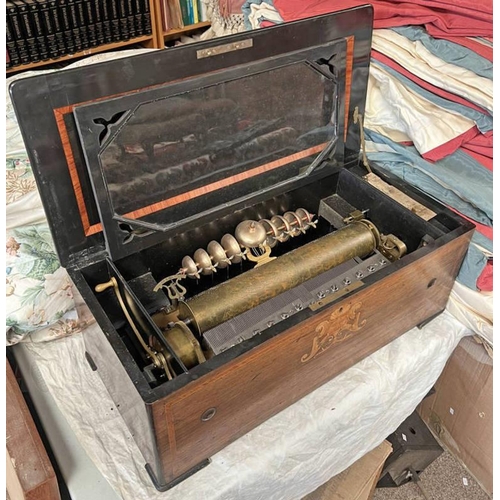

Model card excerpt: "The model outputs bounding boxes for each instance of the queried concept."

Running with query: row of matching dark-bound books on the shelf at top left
[6,0,152,68]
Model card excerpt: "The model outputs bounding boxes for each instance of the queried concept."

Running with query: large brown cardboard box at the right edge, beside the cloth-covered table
[418,337,493,495]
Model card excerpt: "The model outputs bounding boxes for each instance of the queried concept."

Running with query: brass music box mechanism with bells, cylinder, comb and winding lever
[95,201,407,380]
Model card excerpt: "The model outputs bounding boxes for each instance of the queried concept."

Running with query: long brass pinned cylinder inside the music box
[179,220,379,334]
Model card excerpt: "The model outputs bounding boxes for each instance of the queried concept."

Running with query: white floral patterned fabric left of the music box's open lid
[5,49,153,345]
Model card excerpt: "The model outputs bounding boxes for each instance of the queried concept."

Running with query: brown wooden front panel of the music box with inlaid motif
[152,231,472,481]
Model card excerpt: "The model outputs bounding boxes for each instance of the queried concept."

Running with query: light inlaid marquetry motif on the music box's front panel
[300,302,366,363]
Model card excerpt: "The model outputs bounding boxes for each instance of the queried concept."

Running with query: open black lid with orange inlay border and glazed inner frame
[11,6,372,265]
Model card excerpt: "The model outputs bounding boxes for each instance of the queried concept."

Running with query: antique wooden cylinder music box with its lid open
[10,6,473,489]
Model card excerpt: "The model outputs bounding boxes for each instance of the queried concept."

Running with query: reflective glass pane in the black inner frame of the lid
[99,62,338,224]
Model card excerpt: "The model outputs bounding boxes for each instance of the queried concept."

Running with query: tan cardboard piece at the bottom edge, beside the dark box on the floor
[303,441,392,500]
